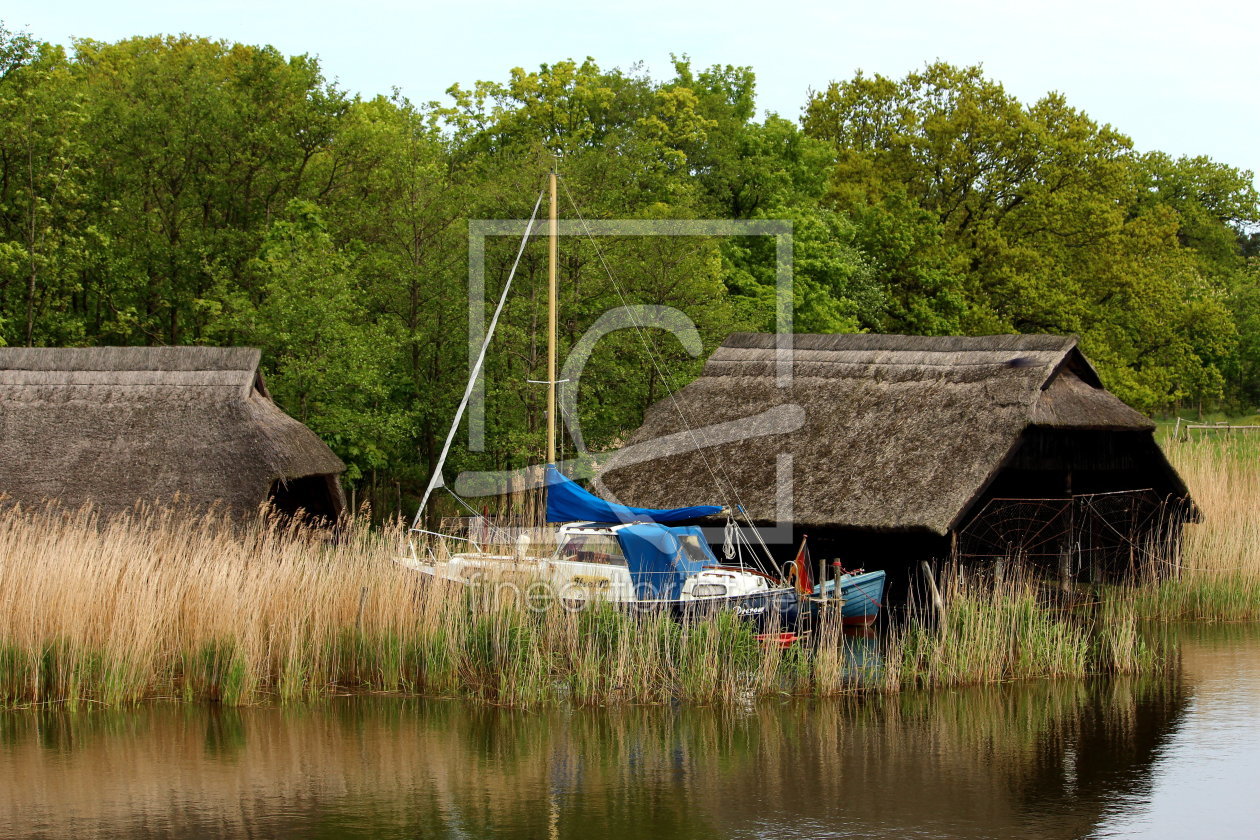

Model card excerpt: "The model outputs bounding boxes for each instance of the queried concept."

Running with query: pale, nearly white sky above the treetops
[0,0,1260,182]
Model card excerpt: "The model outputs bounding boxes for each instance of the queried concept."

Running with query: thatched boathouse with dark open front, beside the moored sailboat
[600,334,1193,578]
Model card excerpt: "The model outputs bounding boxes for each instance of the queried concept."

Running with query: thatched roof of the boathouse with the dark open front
[600,332,1169,534]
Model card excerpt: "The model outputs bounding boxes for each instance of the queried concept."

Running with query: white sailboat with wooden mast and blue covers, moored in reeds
[399,167,800,630]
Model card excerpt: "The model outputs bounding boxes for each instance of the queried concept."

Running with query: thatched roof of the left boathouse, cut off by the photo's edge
[0,348,345,511]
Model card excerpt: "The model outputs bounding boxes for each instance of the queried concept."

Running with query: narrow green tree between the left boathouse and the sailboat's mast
[316,97,470,496]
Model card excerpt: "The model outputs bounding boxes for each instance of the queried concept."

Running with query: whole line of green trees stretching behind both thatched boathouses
[0,26,1260,505]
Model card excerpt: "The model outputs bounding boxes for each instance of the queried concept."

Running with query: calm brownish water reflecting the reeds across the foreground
[0,627,1260,840]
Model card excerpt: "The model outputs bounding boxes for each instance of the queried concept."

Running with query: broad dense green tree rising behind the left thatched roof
[74,35,345,344]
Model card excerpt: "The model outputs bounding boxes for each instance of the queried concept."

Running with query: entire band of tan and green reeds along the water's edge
[0,438,1260,707]
